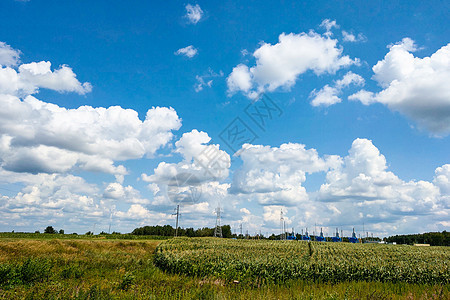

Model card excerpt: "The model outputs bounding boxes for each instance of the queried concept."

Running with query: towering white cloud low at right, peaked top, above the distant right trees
[317,139,449,231]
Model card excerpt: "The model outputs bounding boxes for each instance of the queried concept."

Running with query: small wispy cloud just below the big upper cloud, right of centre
[310,71,364,106]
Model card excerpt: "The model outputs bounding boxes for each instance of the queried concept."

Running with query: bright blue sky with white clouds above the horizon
[0,0,450,236]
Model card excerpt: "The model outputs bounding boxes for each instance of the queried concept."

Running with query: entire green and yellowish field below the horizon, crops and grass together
[0,235,450,299]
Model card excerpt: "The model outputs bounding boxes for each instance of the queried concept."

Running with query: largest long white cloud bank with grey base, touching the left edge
[0,95,181,174]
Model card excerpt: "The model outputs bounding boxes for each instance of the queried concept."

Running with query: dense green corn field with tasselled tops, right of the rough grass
[154,238,450,284]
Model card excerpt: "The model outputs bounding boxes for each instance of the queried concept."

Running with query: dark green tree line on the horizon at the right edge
[386,230,450,246]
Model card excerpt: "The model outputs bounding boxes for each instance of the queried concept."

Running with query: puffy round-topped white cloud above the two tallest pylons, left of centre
[142,129,231,205]
